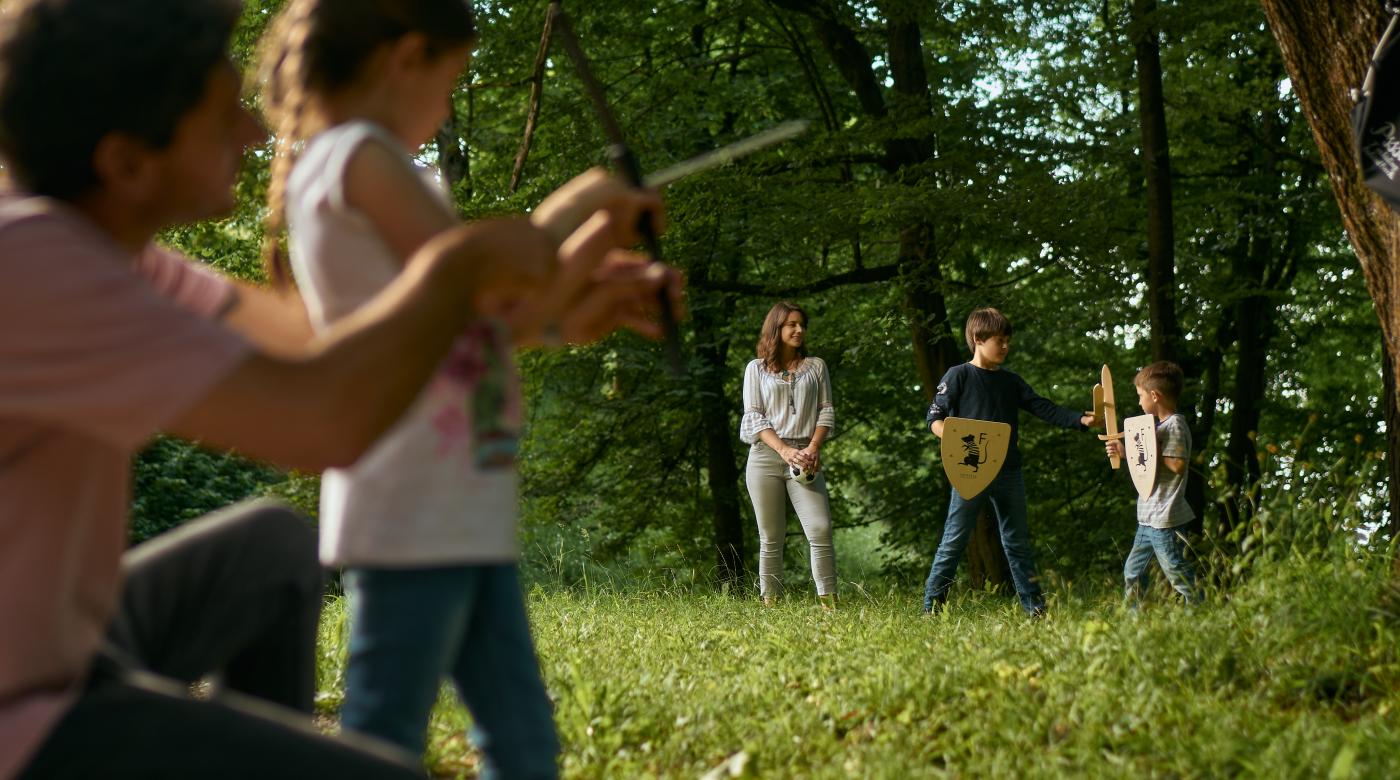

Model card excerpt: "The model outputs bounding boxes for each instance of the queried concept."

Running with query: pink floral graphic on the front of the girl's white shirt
[434,322,521,471]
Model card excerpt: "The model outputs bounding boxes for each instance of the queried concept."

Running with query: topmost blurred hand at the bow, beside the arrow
[531,168,665,246]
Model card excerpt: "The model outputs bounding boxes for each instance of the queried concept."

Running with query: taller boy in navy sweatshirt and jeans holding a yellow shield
[924,308,1095,616]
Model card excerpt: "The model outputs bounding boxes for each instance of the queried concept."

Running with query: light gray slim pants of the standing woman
[743,443,836,597]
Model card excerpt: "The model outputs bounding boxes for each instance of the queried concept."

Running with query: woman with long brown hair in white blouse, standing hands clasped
[739,301,836,609]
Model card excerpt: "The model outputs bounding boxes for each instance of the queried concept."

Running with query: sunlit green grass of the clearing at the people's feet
[312,529,1400,780]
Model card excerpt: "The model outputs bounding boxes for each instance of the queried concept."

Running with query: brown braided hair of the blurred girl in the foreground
[258,0,476,286]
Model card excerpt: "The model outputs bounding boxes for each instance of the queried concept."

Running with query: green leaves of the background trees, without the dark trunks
[137,0,1383,577]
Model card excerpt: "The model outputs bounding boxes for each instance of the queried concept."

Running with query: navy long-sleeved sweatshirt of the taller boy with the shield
[924,363,1089,471]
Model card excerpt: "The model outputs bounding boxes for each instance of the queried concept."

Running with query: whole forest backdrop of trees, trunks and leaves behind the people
[133,0,1400,598]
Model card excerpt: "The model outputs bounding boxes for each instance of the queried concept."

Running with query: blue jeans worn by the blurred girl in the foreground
[340,563,559,777]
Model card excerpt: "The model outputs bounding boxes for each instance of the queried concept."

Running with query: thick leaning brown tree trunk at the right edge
[1261,0,1400,557]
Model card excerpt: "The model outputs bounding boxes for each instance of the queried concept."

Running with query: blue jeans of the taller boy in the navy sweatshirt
[924,468,1046,615]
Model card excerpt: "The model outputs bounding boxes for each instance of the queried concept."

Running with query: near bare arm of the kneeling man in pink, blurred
[169,220,554,471]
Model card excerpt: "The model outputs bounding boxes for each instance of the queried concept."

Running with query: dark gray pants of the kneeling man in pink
[20,503,423,780]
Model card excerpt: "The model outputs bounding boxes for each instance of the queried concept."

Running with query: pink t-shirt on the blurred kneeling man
[0,195,249,779]
